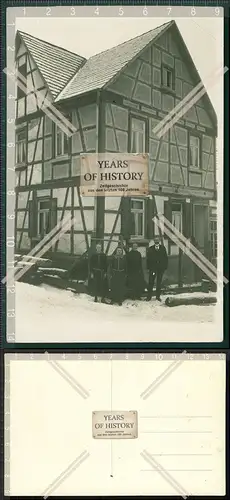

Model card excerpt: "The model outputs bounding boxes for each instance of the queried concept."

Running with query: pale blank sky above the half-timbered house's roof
[13,8,223,115]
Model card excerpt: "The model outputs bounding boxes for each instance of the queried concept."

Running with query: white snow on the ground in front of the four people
[16,282,221,343]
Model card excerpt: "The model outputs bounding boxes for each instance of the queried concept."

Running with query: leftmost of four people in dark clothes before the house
[89,243,107,302]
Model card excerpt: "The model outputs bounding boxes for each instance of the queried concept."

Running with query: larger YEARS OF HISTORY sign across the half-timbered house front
[80,153,149,196]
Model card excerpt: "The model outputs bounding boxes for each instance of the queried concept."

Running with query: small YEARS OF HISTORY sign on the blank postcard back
[92,411,138,439]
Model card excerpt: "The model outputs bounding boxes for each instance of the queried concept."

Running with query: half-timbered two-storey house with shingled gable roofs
[16,21,217,281]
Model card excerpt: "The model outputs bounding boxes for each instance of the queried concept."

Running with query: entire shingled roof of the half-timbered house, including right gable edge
[16,20,217,127]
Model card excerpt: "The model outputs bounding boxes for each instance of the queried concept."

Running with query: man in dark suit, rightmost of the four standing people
[147,238,168,301]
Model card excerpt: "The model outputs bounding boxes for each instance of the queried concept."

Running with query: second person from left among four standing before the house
[110,247,127,306]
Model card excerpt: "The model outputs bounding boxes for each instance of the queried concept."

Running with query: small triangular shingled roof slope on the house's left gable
[17,31,86,99]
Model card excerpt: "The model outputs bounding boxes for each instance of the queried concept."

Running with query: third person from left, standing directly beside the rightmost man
[127,243,145,300]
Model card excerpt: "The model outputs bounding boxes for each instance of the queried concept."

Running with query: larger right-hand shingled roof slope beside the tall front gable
[56,21,173,102]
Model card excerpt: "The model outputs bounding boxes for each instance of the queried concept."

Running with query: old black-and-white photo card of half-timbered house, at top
[7,7,224,343]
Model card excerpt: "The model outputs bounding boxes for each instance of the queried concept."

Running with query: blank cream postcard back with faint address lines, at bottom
[5,351,227,498]
